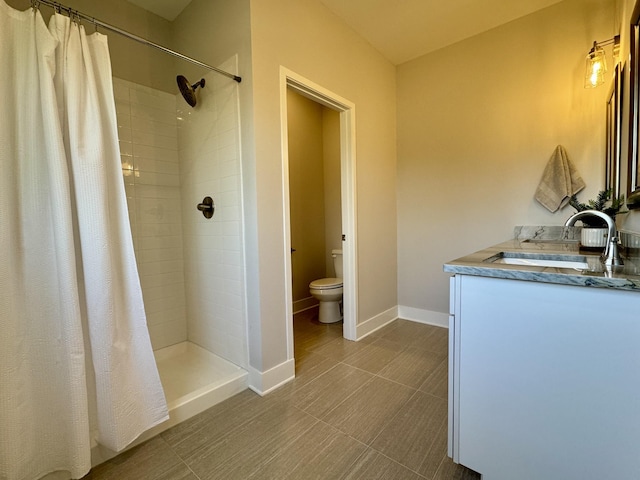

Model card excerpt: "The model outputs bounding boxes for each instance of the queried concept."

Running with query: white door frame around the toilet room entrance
[280,66,358,359]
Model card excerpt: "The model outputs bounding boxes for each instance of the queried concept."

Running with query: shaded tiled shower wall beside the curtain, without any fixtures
[113,78,187,349]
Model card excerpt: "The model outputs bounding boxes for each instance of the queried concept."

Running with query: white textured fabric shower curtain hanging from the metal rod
[0,0,168,480]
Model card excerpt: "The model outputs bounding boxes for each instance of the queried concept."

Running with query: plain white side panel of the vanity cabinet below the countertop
[449,274,640,480]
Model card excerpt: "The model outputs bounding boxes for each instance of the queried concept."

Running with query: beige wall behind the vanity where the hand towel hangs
[397,0,617,312]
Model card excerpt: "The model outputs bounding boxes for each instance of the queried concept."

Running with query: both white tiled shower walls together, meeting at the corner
[114,57,247,367]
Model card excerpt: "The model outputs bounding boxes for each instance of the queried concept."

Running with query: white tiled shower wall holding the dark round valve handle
[177,57,248,367]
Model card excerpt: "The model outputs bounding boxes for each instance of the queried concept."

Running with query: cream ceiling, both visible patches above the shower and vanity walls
[129,0,562,65]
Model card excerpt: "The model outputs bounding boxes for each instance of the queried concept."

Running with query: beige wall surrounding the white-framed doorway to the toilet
[250,0,397,371]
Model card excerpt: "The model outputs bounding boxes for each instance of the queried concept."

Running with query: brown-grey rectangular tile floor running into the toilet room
[84,309,480,480]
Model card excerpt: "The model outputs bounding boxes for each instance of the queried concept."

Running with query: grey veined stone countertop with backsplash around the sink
[444,227,640,292]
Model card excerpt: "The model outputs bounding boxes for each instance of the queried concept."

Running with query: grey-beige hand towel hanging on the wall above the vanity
[535,145,586,212]
